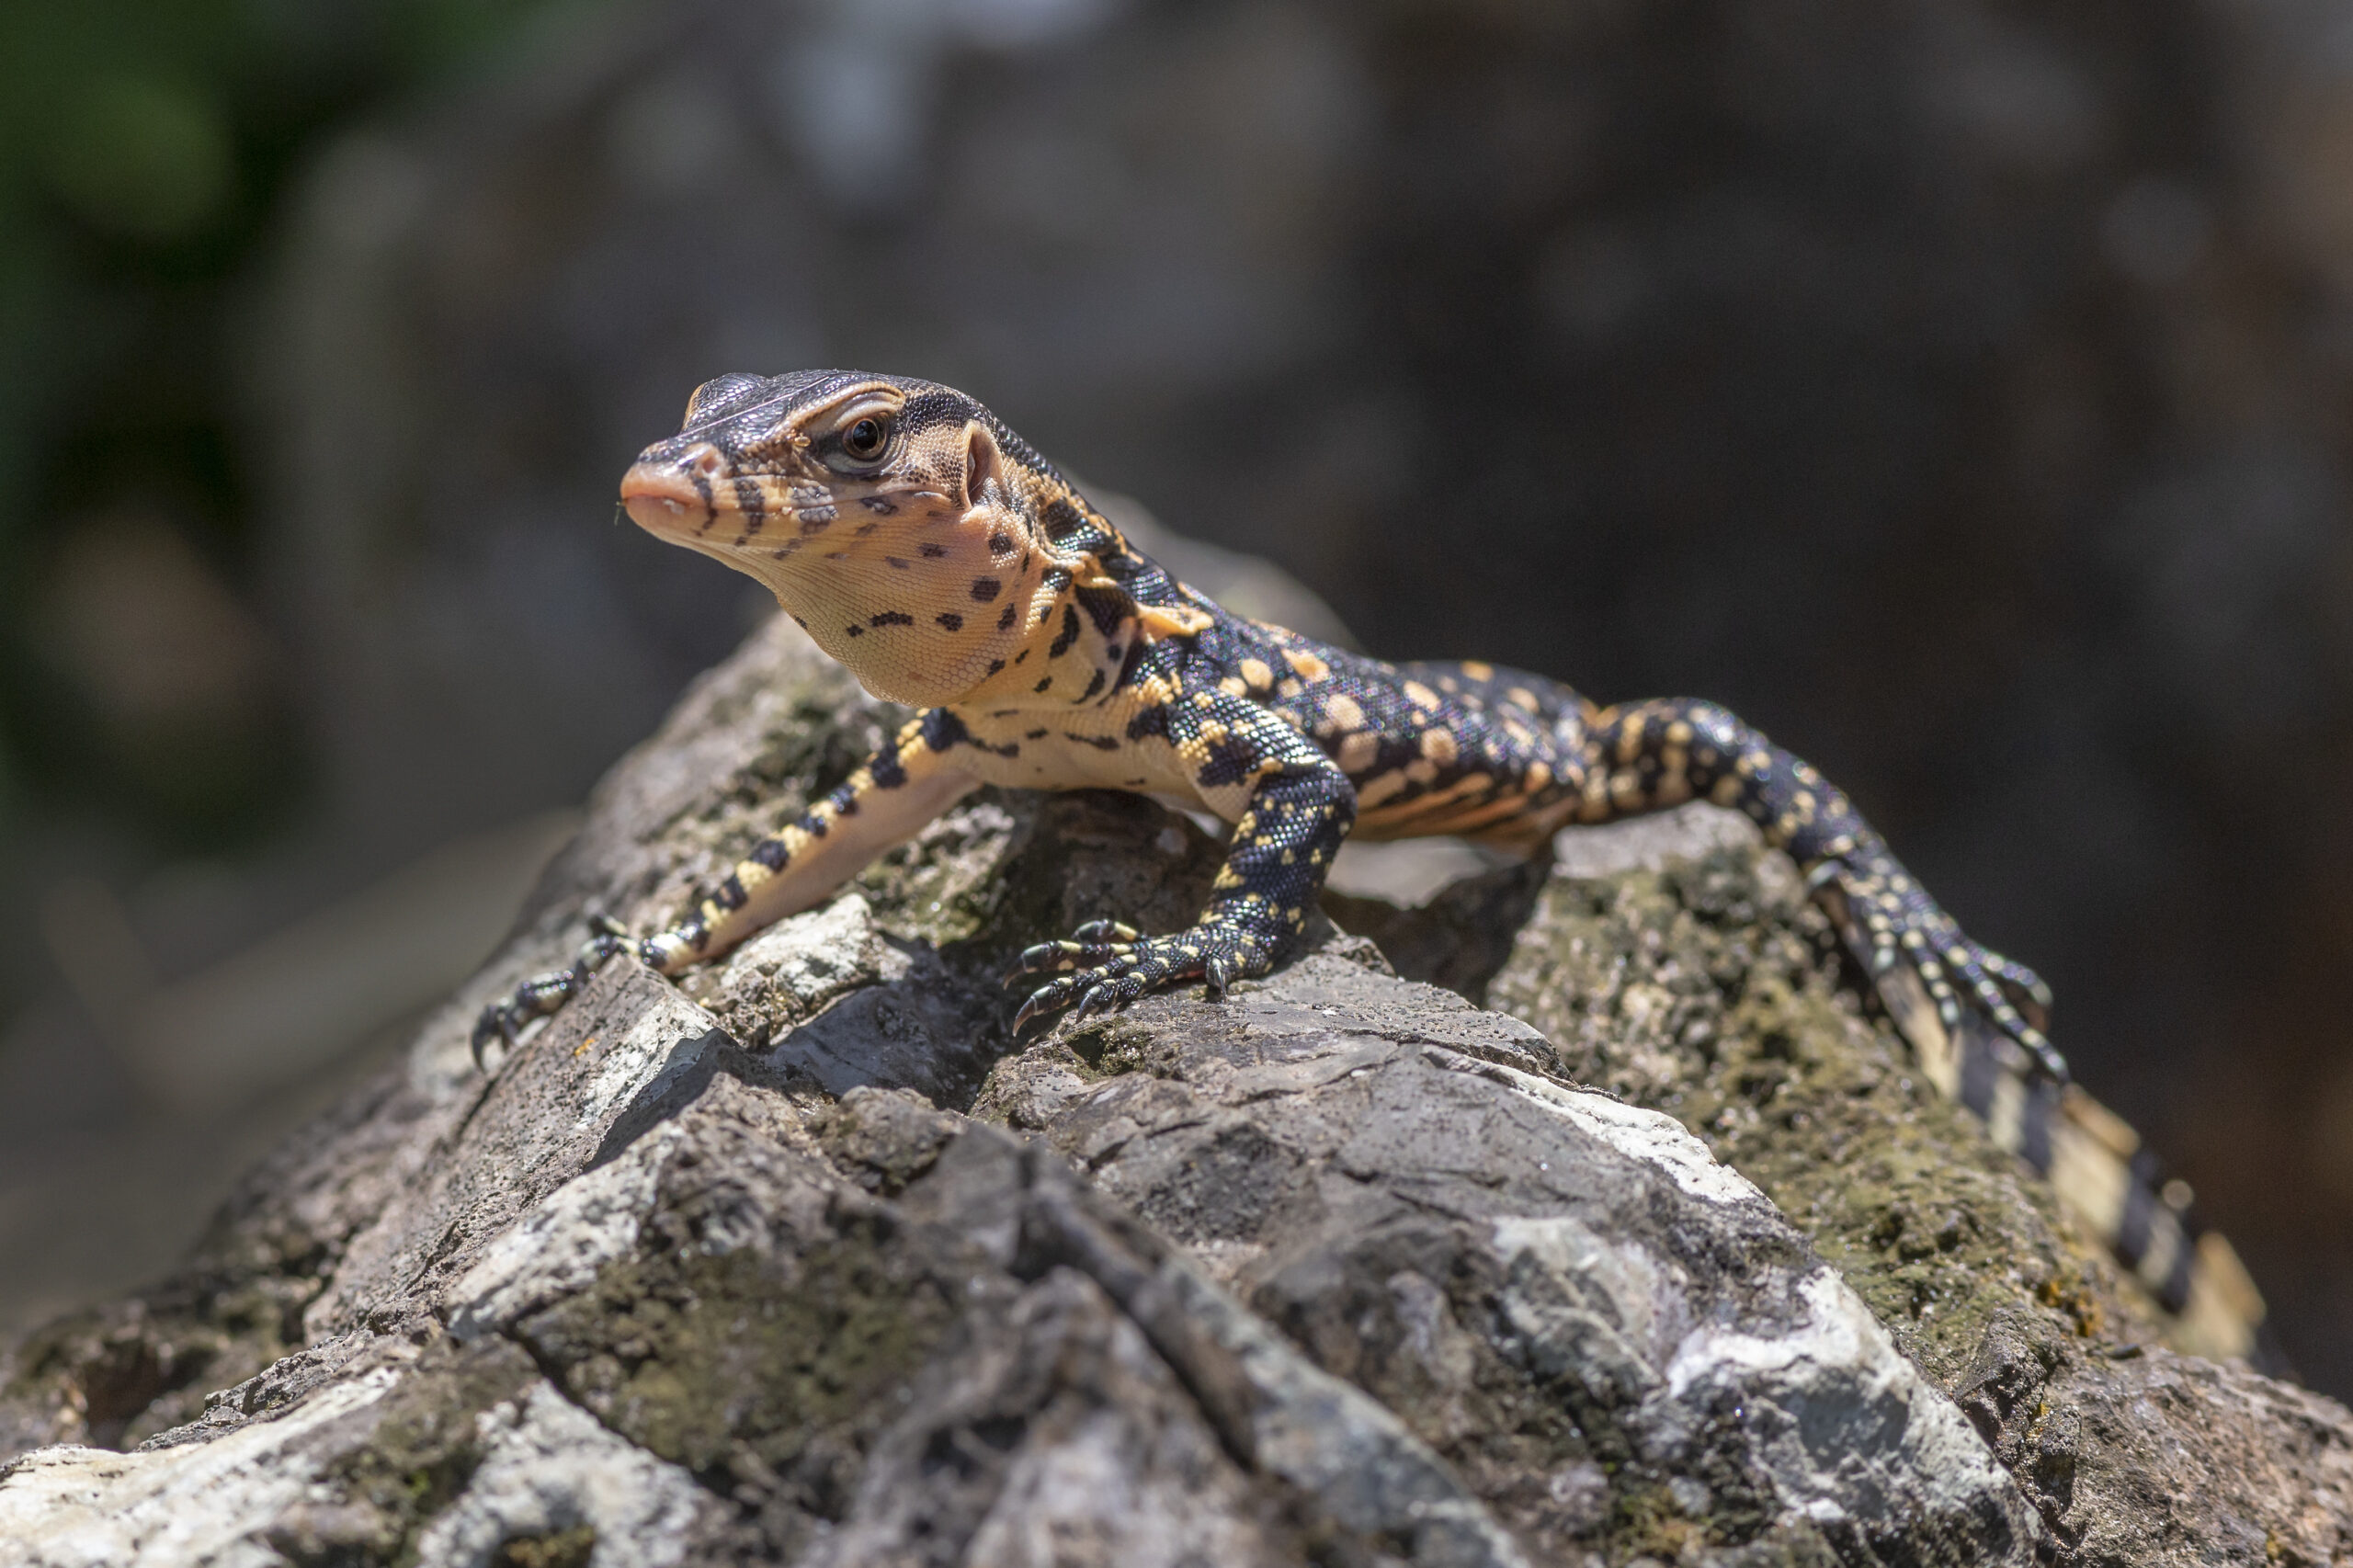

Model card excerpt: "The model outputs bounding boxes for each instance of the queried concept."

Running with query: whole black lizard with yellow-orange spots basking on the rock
[475,372,2258,1356]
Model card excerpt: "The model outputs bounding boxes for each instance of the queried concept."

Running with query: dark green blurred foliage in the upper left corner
[0,0,546,855]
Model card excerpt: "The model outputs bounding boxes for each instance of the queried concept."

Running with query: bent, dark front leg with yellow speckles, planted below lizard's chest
[1007,704,1356,1034]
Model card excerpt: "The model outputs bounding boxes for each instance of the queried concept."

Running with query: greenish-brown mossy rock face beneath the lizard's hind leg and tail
[1487,850,2155,1387]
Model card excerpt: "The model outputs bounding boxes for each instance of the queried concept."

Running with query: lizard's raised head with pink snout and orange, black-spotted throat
[621,369,1077,706]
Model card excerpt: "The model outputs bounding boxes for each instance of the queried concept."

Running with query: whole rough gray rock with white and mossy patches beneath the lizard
[0,621,2353,1568]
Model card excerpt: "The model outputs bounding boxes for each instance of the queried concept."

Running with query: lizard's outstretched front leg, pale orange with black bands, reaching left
[473,709,979,1066]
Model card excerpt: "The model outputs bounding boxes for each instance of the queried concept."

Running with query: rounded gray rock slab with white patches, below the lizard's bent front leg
[979,956,2033,1561]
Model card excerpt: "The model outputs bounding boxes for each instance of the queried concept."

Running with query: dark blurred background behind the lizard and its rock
[0,0,2353,1396]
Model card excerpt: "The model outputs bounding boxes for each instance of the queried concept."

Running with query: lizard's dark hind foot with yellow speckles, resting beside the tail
[1807,847,2068,1083]
